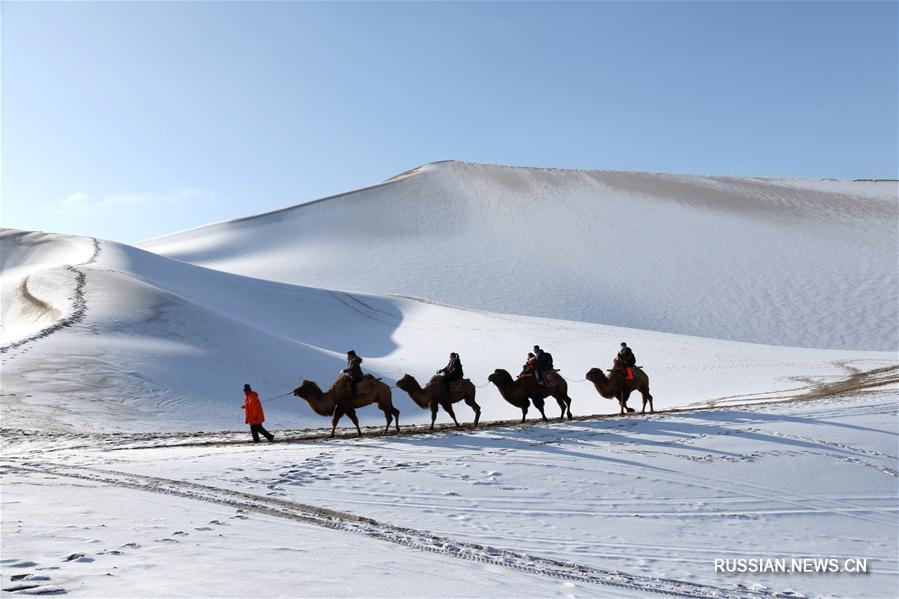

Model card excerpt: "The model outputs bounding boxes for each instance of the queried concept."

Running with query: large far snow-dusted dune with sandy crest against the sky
[140,162,899,351]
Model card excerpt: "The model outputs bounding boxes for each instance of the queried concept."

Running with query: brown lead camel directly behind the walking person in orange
[293,374,400,437]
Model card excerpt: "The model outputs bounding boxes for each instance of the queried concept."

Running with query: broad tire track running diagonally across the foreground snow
[2,458,796,599]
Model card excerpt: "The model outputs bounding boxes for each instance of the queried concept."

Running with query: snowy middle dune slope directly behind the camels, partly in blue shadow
[0,231,895,431]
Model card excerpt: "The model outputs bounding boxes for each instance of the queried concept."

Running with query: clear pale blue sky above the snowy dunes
[0,2,899,242]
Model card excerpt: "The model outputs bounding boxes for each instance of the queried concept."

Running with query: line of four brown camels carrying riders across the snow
[286,343,654,440]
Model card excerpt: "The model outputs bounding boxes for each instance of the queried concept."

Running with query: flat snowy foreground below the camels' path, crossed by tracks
[0,396,899,599]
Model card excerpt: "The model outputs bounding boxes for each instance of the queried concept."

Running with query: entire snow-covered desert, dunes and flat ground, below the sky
[0,162,899,597]
